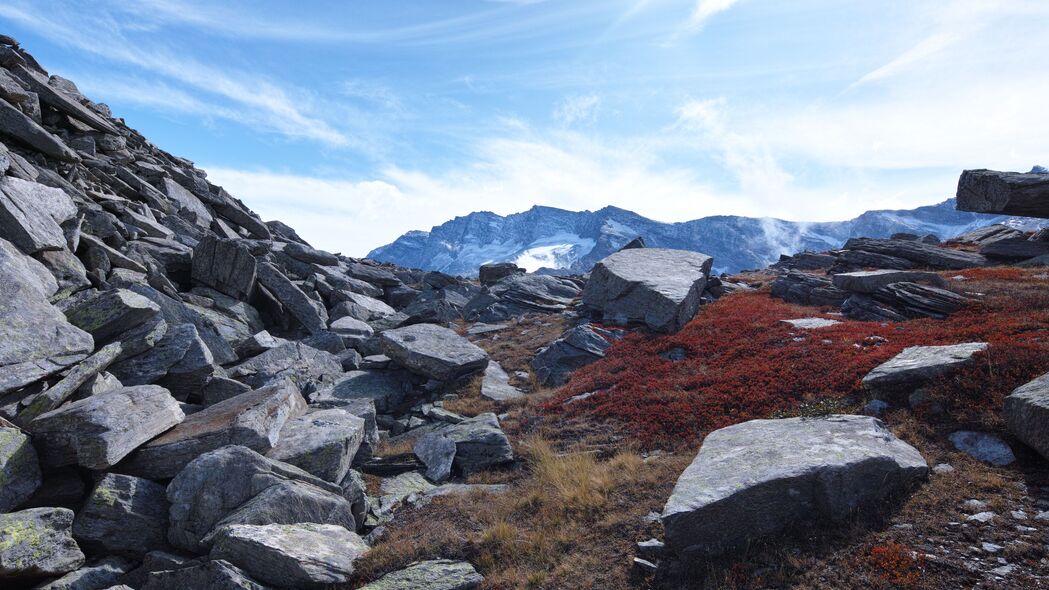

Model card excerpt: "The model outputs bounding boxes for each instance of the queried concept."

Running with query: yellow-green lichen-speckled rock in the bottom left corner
[0,508,84,582]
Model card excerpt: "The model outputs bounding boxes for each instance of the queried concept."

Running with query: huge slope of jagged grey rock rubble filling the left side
[0,38,495,589]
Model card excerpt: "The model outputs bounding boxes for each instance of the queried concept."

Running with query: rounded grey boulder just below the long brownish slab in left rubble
[168,446,357,552]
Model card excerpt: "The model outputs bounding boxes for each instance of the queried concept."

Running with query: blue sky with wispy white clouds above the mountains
[0,0,1049,256]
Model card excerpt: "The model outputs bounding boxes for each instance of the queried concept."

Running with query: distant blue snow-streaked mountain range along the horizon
[368,199,1034,275]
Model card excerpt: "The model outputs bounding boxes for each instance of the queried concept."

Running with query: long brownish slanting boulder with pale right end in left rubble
[121,381,306,480]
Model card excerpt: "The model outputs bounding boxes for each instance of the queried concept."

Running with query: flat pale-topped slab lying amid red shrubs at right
[862,342,987,397]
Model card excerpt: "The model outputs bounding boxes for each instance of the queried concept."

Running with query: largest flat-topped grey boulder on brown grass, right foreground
[662,416,928,559]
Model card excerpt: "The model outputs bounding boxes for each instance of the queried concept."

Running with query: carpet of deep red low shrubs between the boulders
[547,272,1049,445]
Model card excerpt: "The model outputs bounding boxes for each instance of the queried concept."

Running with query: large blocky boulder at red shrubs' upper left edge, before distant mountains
[582,248,713,332]
